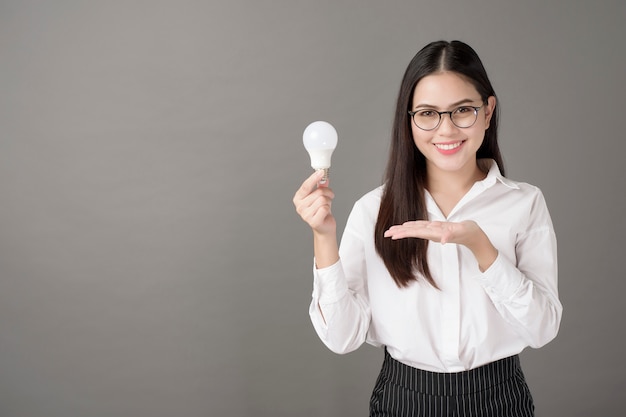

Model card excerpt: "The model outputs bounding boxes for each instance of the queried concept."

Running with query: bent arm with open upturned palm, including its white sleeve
[385,192,562,347]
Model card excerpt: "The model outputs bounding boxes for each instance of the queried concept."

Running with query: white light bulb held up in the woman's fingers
[302,121,337,184]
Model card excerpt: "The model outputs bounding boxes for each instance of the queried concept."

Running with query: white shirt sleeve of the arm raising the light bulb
[309,200,371,354]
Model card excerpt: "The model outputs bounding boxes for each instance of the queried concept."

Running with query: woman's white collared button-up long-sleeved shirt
[309,161,562,372]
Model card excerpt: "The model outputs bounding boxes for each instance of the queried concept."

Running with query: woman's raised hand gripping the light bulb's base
[293,170,337,236]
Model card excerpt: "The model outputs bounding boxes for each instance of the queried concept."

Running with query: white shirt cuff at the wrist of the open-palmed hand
[476,252,524,301]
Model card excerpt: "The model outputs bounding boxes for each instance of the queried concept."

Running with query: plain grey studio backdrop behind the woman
[0,0,626,417]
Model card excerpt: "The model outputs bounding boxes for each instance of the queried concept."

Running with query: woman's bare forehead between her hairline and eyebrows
[413,72,480,108]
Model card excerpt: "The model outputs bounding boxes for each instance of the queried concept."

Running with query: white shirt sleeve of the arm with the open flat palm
[476,191,563,348]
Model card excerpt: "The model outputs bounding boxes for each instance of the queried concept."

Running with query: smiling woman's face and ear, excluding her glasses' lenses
[411,72,496,175]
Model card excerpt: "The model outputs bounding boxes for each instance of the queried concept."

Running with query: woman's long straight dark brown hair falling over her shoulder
[374,41,504,288]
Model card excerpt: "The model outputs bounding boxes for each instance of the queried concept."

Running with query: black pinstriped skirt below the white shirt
[370,350,535,417]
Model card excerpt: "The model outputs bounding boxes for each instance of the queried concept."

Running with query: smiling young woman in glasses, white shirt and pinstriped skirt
[293,41,562,417]
